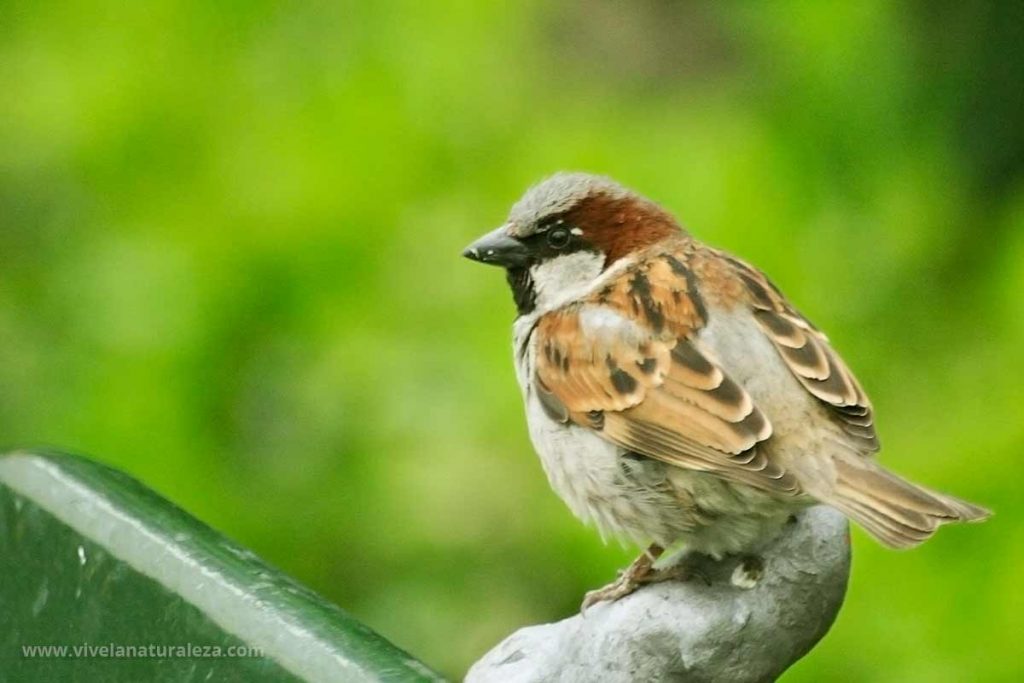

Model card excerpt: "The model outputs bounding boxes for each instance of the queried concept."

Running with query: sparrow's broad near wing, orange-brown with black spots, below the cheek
[534,250,800,494]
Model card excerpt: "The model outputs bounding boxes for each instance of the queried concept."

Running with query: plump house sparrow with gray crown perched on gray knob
[464,173,989,607]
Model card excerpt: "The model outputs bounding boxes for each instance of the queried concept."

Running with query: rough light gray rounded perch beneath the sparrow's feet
[466,506,850,683]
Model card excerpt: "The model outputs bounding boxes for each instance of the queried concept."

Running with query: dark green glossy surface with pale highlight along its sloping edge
[0,453,448,682]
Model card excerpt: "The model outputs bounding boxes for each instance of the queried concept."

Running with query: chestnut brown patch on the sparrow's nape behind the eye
[565,194,684,267]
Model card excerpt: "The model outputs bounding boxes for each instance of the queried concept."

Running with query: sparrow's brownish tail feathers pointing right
[825,459,991,548]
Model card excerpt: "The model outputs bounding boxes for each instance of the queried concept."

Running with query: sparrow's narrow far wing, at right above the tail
[717,252,880,455]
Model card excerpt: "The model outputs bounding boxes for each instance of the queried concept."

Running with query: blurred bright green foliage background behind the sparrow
[0,0,1024,683]
